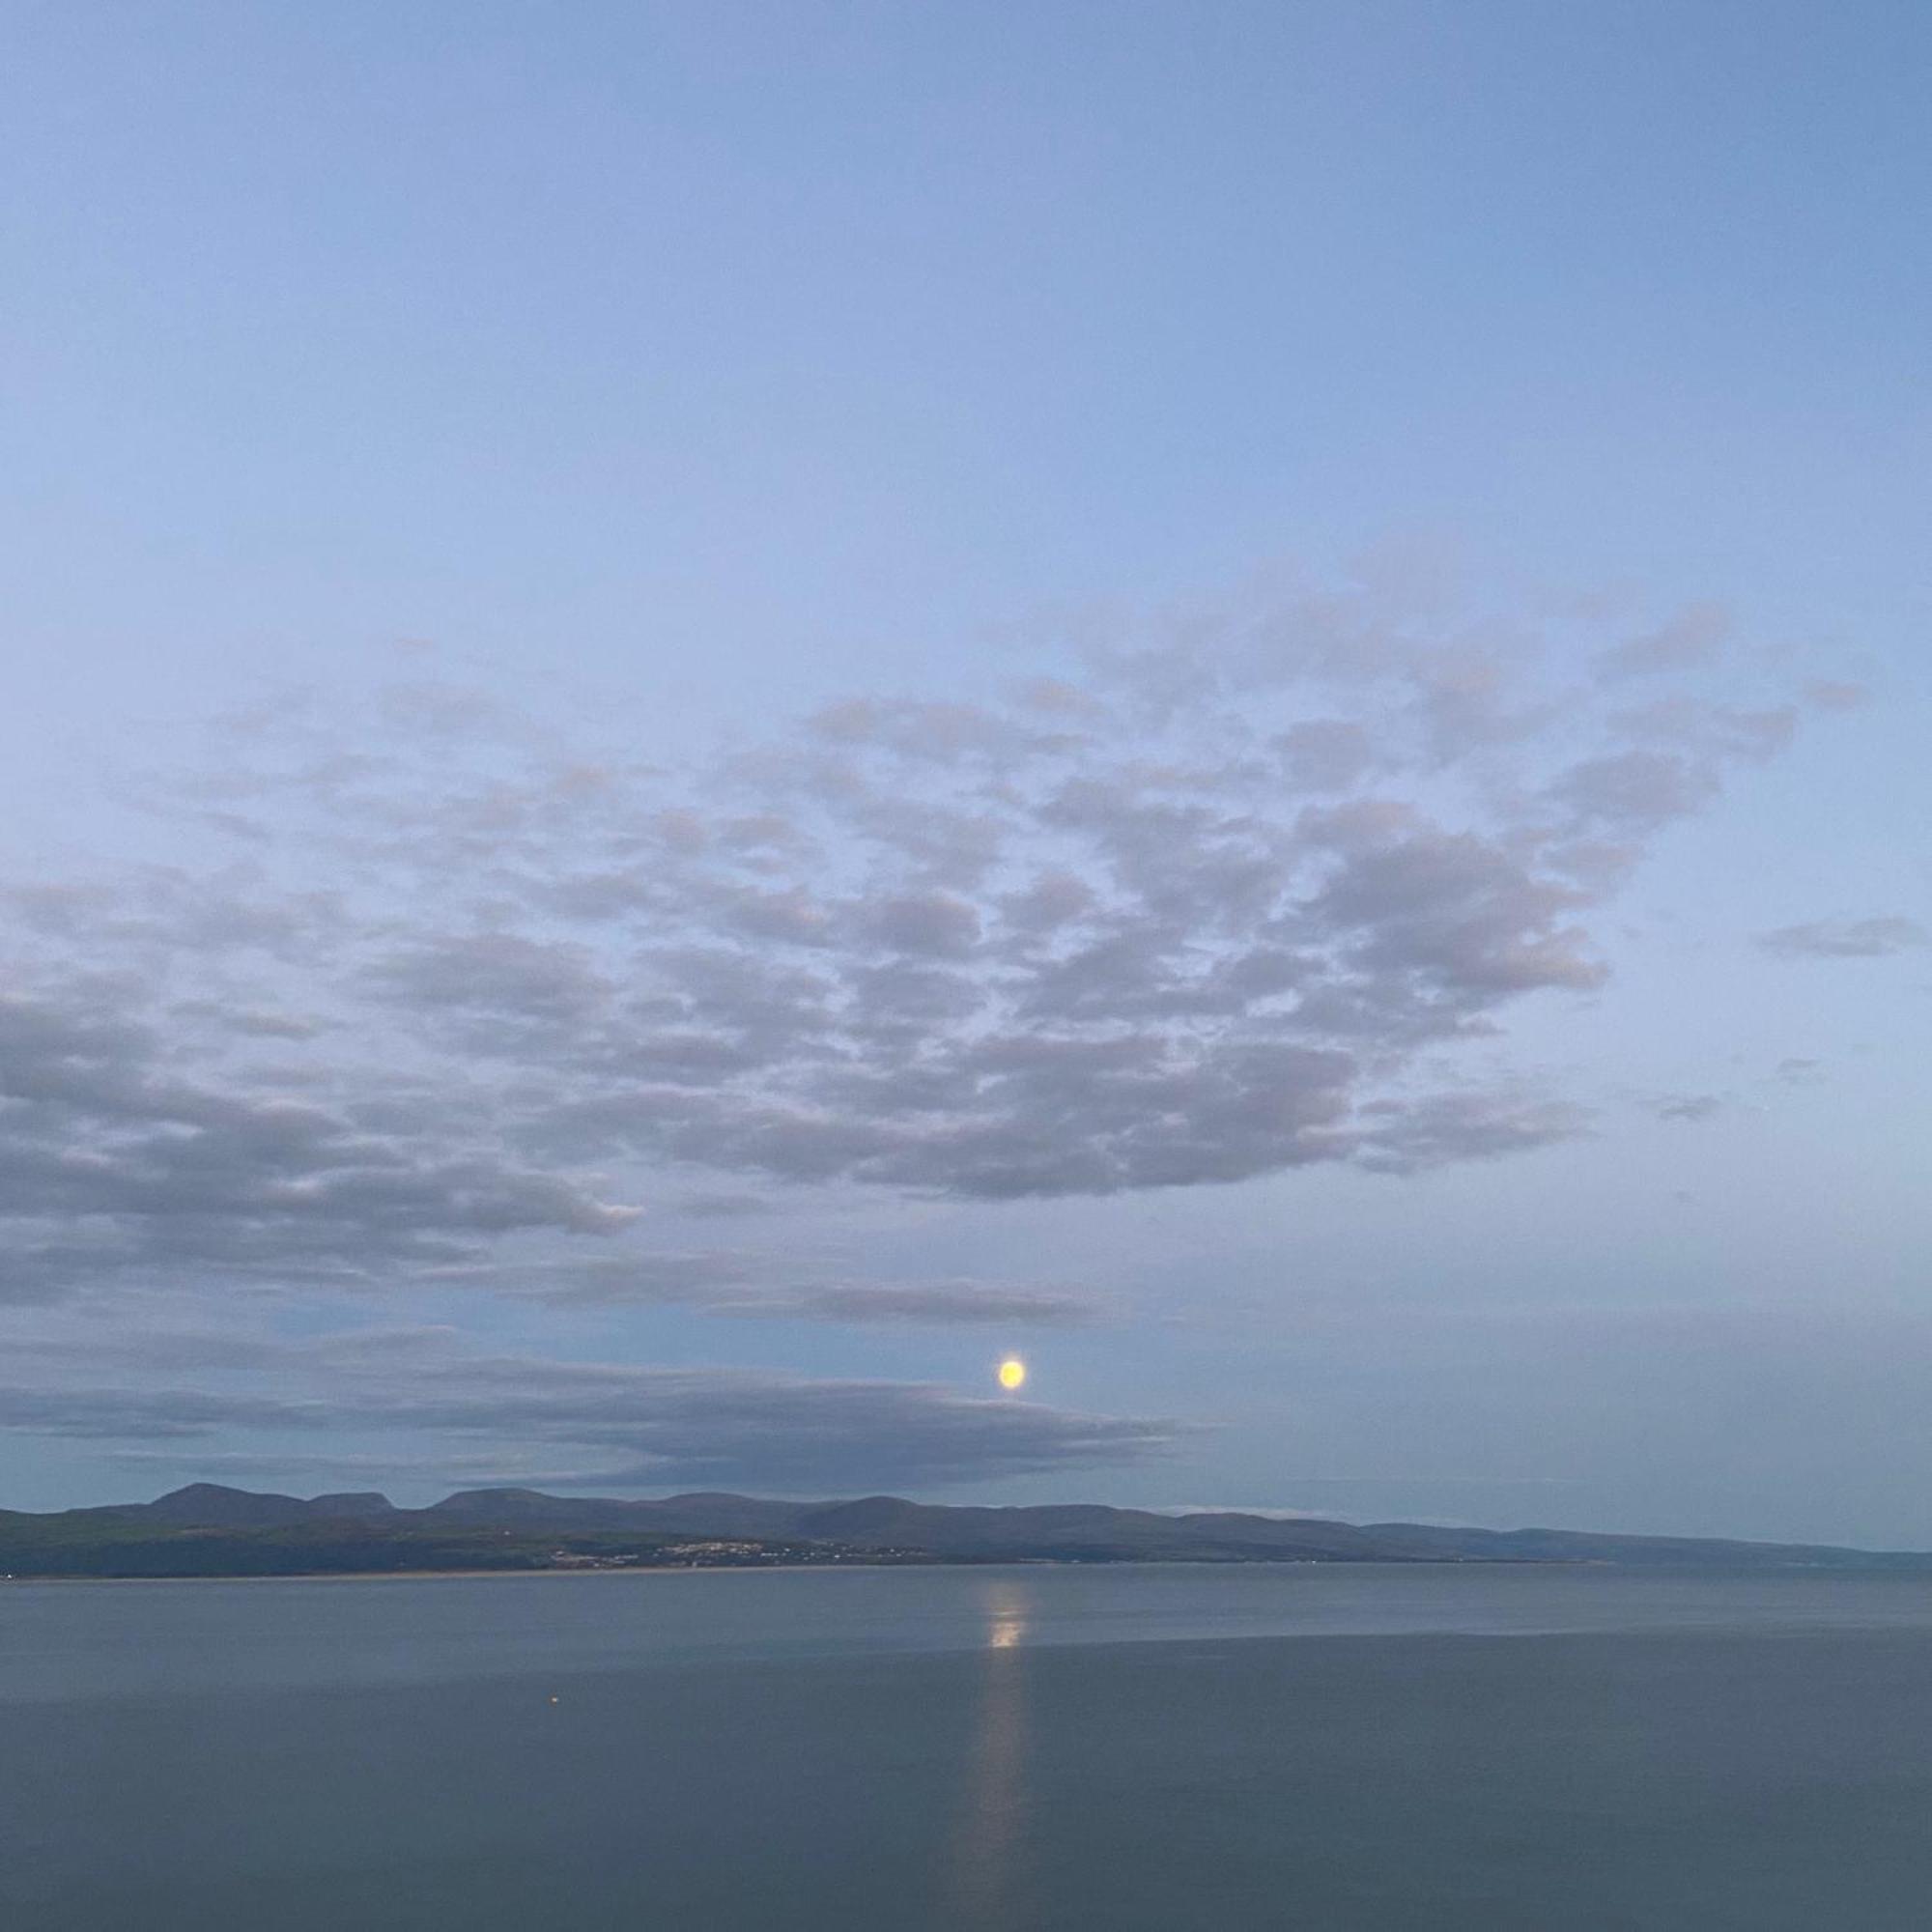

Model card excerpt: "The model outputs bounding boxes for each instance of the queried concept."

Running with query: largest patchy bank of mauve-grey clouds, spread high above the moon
[0,564,1824,1320]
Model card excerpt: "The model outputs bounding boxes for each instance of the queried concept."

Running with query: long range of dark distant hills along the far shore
[0,1482,1932,1577]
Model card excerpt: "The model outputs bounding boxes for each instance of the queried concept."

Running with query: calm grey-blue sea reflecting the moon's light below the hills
[0,1567,1932,1932]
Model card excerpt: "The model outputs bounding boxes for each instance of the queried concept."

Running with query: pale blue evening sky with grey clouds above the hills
[0,0,1932,1546]
